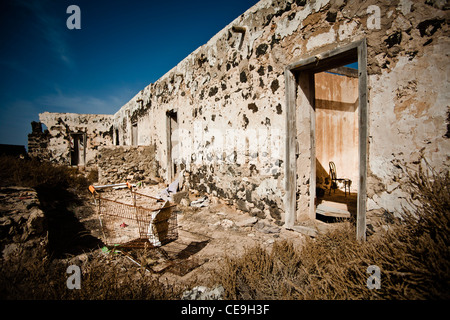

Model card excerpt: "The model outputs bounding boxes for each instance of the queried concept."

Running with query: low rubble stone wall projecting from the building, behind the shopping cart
[97,146,158,184]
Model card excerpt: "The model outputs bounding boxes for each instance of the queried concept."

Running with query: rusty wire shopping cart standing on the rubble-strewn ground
[89,183,178,249]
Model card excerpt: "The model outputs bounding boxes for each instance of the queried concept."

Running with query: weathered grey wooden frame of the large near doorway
[284,39,368,240]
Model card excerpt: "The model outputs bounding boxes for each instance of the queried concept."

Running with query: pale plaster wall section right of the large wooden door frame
[367,37,450,212]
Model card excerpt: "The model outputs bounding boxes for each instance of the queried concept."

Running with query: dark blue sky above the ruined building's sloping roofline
[0,0,258,146]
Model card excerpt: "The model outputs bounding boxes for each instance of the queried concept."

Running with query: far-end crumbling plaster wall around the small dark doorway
[39,112,113,166]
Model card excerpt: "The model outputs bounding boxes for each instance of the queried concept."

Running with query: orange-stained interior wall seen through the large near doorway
[315,72,359,192]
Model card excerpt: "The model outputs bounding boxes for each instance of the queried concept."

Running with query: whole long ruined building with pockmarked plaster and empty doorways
[29,0,450,238]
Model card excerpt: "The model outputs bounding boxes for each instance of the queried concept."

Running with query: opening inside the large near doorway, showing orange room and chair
[314,64,359,222]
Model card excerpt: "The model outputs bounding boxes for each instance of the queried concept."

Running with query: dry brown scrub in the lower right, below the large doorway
[218,168,450,299]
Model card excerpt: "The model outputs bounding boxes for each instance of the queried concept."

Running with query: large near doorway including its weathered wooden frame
[285,39,367,240]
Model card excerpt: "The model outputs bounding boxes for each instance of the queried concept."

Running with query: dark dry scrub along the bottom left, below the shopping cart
[0,250,184,300]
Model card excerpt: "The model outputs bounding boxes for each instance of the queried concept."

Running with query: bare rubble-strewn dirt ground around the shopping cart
[80,186,305,286]
